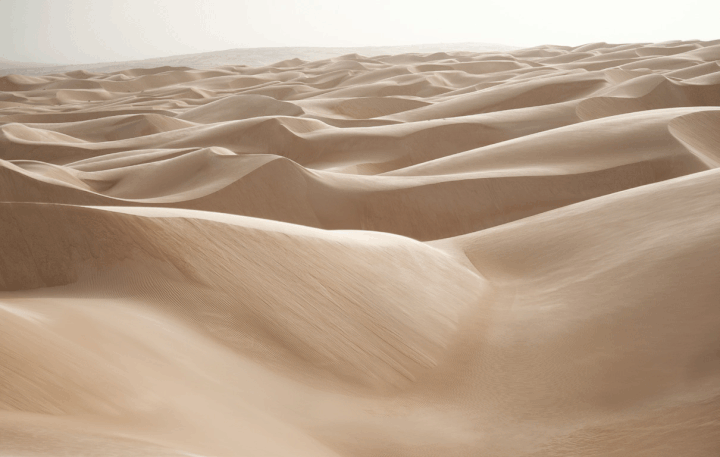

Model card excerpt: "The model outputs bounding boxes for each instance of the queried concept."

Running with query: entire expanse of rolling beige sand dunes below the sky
[0,40,720,457]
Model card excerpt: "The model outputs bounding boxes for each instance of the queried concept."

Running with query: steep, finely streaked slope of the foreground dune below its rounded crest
[0,204,483,385]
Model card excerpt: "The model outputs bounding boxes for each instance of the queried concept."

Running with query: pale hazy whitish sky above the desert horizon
[0,0,720,63]
